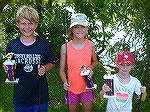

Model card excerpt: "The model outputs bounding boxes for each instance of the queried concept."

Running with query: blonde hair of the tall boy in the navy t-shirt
[16,6,39,23]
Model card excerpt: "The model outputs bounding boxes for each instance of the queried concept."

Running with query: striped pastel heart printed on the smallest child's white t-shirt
[116,91,129,107]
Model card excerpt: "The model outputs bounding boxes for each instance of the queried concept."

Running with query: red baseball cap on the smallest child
[116,51,135,65]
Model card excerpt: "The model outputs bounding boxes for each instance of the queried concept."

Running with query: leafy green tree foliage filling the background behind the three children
[0,0,150,112]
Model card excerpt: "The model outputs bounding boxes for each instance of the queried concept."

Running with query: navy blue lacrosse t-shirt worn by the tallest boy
[6,37,55,105]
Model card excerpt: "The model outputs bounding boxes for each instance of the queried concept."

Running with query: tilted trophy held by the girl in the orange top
[81,65,97,89]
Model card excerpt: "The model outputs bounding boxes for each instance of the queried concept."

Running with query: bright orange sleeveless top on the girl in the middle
[67,39,92,94]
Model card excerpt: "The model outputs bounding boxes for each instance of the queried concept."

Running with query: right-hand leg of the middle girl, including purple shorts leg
[80,90,93,112]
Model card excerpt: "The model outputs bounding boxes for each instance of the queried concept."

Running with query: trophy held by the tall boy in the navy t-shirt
[3,53,19,84]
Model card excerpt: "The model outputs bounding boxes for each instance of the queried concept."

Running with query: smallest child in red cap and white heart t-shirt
[100,51,146,112]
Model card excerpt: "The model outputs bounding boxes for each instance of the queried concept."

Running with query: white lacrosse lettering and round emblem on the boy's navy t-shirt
[14,54,41,72]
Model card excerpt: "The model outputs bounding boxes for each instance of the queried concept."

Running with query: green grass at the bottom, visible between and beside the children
[0,63,150,112]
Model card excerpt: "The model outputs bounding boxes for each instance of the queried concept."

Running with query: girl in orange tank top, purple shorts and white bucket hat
[60,13,97,112]
